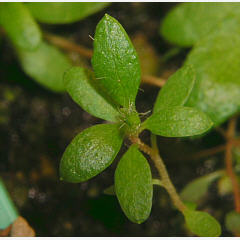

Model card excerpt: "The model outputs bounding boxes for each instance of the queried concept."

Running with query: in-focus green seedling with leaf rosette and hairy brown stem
[60,14,221,236]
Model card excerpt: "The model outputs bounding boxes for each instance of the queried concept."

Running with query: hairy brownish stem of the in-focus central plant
[130,135,186,213]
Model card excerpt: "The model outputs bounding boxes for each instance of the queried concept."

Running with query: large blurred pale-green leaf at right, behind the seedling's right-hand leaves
[185,17,240,125]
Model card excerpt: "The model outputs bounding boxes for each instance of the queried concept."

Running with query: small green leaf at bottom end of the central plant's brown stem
[184,209,221,237]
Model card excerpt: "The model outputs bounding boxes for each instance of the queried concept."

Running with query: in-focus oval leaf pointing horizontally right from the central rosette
[143,106,212,137]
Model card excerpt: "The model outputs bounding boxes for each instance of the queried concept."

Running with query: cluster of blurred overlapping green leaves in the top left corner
[0,2,109,92]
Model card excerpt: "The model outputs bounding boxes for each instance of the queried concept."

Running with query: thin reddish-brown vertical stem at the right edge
[225,117,240,213]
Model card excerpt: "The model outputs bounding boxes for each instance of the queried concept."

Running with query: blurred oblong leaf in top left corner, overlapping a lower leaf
[0,2,42,50]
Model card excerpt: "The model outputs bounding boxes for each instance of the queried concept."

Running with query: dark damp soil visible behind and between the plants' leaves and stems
[0,3,233,237]
